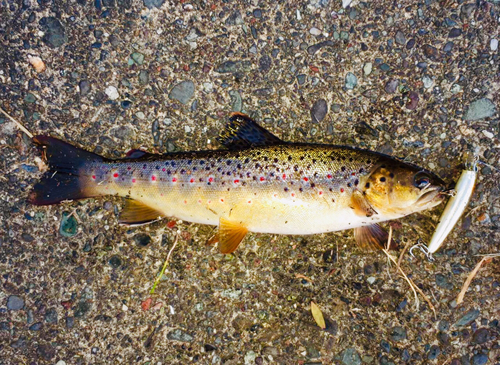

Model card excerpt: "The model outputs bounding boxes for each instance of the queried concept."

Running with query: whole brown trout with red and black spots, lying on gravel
[28,113,445,254]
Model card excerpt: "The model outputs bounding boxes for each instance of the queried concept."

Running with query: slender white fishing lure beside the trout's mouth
[428,154,477,254]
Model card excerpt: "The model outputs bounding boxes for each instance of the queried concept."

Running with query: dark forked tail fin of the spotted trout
[28,136,104,205]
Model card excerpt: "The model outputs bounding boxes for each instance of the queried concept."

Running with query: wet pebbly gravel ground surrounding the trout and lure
[0,0,500,365]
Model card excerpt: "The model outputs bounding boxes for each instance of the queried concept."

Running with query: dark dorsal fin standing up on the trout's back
[217,113,285,150]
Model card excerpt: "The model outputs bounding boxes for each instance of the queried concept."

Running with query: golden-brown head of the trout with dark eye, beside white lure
[363,161,446,216]
